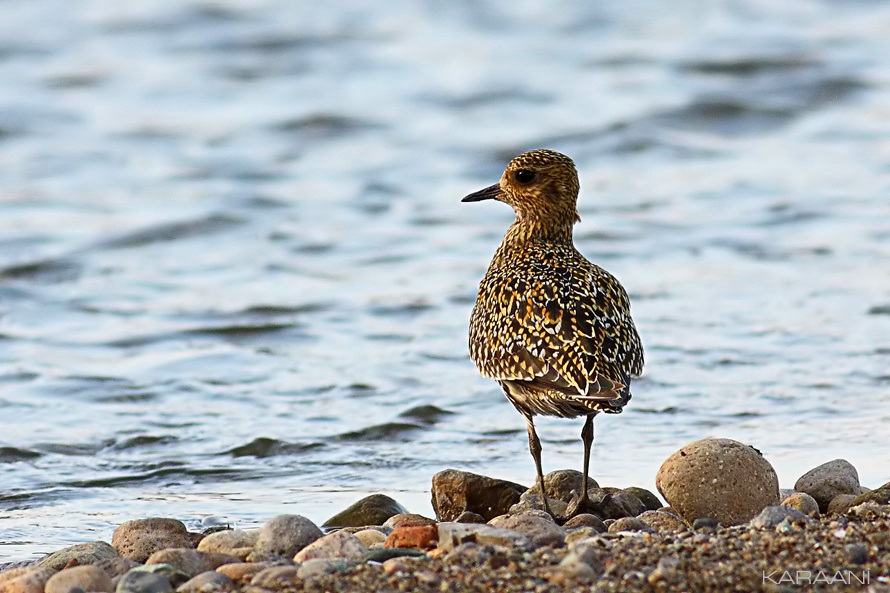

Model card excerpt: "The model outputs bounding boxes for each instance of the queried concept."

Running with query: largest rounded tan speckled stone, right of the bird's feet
[655,439,779,525]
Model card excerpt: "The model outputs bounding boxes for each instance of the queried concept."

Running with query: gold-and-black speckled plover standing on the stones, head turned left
[462,150,643,516]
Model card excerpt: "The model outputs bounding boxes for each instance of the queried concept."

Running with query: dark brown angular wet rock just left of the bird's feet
[432,469,526,522]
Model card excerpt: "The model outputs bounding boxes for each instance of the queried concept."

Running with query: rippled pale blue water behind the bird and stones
[0,0,890,560]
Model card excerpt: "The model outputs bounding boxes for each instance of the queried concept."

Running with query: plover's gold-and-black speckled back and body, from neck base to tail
[470,225,643,417]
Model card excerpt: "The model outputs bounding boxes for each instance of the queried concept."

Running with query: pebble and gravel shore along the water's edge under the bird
[0,439,890,593]
